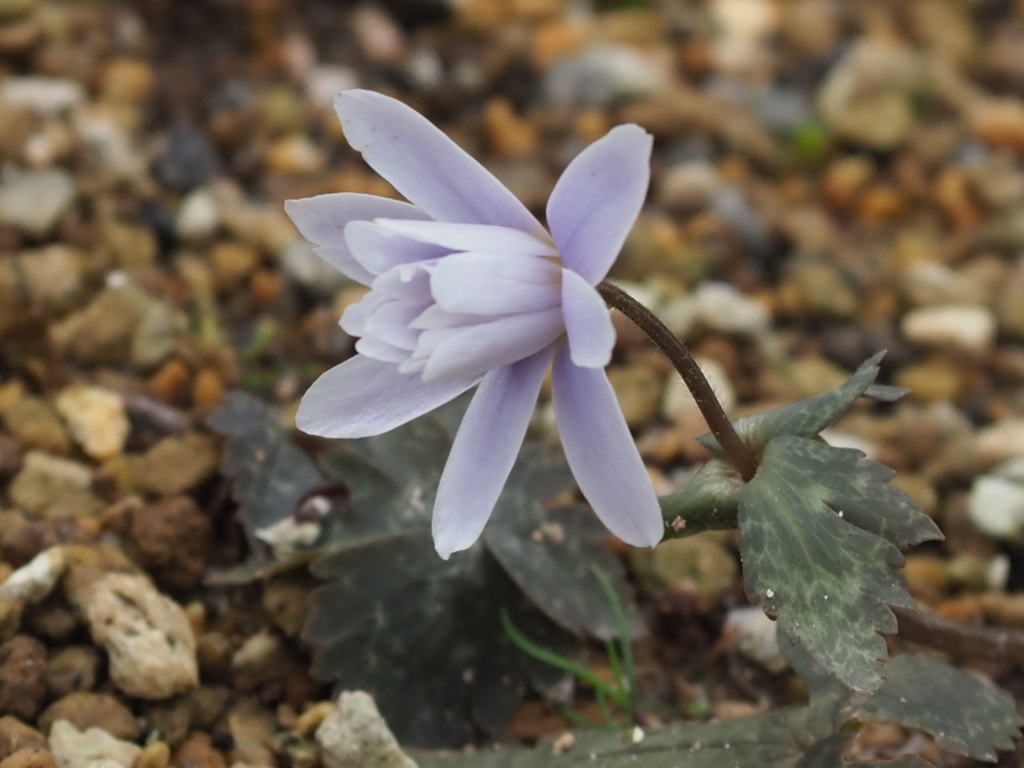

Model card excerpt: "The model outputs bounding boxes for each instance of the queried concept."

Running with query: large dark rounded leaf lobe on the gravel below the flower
[303,529,567,746]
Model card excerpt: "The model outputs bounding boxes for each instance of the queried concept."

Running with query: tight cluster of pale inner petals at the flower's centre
[341,219,565,381]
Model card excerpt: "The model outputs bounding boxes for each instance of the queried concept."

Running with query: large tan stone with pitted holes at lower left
[71,573,199,699]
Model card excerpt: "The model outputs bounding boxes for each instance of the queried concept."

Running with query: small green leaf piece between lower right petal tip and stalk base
[658,459,743,538]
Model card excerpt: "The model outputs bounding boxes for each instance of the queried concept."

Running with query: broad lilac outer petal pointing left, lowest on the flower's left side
[295,355,479,437]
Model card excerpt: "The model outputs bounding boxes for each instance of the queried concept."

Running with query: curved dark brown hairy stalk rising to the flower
[597,281,758,481]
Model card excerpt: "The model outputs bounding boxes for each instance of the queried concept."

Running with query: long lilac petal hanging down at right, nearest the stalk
[552,346,665,547]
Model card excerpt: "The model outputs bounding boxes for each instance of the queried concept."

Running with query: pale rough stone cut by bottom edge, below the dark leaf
[316,691,416,768]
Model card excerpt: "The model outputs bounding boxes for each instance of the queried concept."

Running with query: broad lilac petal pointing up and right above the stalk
[548,125,653,286]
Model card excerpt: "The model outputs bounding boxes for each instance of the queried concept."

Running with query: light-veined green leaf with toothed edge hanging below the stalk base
[739,436,913,692]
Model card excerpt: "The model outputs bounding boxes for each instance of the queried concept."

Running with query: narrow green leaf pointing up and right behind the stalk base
[697,352,892,458]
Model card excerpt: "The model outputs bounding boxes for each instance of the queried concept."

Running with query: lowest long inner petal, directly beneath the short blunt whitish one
[413,309,563,381]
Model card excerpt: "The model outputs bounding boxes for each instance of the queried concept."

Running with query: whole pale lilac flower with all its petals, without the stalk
[286,90,664,558]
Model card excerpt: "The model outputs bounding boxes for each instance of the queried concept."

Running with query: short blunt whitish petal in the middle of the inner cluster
[430,253,565,315]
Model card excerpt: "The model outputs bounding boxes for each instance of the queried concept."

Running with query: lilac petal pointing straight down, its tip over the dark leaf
[433,349,551,560]
